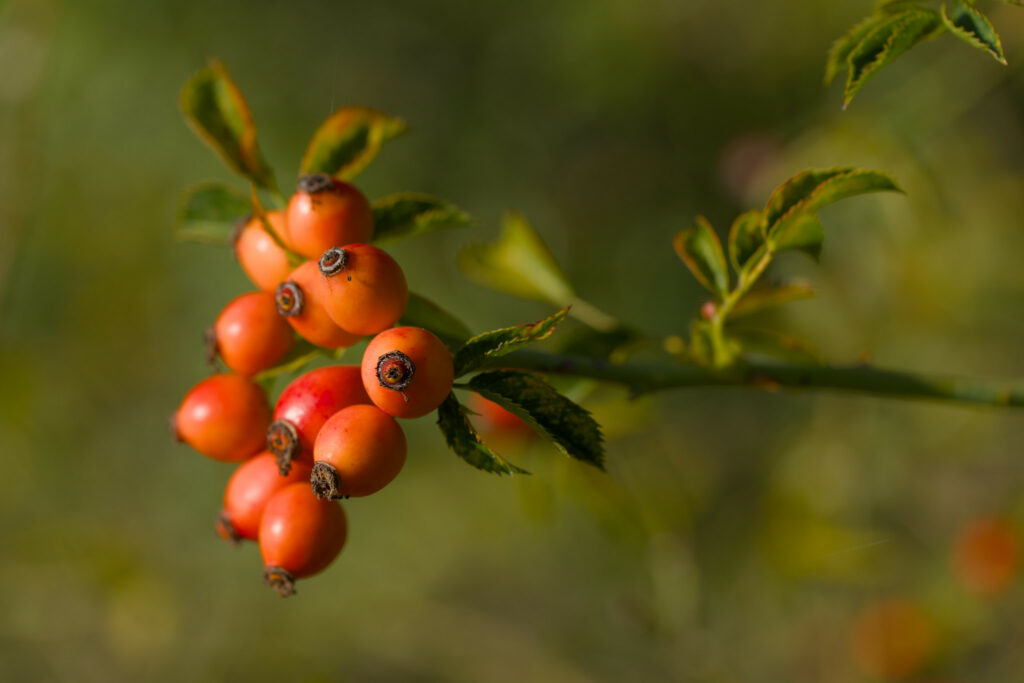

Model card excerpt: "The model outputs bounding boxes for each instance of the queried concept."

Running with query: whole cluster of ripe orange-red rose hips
[173,174,454,596]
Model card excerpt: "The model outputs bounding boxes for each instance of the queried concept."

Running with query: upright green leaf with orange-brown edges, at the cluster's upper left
[180,61,276,189]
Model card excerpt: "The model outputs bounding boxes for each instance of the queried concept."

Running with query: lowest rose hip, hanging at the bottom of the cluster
[259,483,348,597]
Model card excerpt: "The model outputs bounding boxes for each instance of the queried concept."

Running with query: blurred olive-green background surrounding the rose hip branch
[6,0,1024,683]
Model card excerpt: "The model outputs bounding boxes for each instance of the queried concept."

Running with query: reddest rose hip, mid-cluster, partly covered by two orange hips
[266,366,370,472]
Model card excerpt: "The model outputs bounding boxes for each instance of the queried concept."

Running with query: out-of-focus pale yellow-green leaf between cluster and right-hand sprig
[459,213,575,306]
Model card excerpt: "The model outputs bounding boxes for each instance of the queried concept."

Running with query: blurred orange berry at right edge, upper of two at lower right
[953,517,1020,597]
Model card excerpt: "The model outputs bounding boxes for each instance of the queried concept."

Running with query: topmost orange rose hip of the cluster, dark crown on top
[285,173,374,259]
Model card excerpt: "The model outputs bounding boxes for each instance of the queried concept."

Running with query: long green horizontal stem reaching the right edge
[486,351,1024,408]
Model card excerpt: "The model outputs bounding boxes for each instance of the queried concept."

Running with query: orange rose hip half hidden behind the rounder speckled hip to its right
[274,261,359,348]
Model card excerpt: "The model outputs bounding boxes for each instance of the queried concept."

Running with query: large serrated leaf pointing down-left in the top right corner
[843,8,942,109]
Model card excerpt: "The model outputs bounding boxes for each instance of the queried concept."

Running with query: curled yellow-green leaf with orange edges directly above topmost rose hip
[301,106,407,180]
